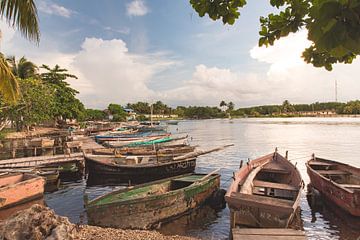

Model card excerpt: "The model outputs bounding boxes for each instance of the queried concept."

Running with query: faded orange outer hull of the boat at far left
[0,174,45,209]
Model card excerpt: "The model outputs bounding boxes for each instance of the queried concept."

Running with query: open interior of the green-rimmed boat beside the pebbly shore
[95,174,205,205]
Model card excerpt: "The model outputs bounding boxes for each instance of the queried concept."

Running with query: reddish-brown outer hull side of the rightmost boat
[306,158,360,217]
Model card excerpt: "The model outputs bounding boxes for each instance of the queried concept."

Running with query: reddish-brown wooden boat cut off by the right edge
[306,155,360,217]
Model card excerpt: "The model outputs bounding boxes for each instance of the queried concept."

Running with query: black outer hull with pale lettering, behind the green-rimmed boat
[85,157,196,183]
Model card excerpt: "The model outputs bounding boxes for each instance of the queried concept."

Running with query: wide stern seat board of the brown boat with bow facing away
[230,192,294,213]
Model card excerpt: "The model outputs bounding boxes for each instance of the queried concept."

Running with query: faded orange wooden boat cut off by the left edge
[0,173,45,209]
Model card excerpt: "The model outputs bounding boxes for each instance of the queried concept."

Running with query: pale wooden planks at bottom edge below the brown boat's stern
[231,228,307,240]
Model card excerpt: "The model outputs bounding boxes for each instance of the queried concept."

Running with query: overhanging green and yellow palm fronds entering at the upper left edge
[0,0,40,101]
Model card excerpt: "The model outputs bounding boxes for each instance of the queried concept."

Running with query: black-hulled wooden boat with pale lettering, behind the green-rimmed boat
[85,155,196,183]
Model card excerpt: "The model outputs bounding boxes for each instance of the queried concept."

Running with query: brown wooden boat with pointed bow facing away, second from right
[225,151,304,228]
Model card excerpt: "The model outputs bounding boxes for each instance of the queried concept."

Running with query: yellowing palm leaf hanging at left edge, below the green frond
[0,56,19,102]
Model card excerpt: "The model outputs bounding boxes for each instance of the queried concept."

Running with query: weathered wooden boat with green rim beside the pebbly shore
[86,174,220,229]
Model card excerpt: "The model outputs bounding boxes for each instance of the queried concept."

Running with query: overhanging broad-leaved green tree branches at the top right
[190,0,360,71]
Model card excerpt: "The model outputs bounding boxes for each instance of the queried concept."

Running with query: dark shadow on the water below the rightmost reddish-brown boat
[306,184,360,240]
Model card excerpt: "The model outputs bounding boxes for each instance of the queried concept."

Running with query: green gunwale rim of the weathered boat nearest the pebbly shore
[85,173,220,210]
